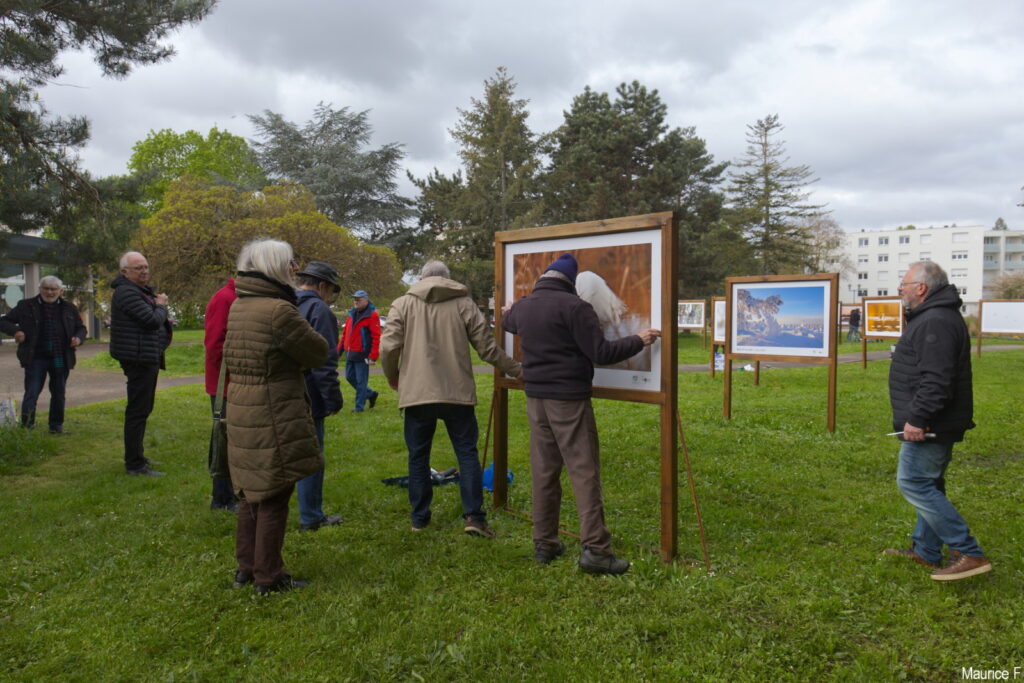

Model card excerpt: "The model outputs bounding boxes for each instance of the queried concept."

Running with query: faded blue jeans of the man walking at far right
[896,441,985,564]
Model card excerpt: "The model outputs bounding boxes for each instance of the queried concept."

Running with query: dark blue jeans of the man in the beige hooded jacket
[406,403,486,526]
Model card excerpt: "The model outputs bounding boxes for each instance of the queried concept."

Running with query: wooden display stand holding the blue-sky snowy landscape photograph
[722,272,839,432]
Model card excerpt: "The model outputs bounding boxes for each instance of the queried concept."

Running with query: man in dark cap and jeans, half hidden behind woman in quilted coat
[295,261,343,531]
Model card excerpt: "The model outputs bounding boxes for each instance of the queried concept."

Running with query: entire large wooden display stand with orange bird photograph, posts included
[494,211,696,562]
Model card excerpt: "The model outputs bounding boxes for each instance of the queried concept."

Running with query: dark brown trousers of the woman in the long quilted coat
[234,485,295,586]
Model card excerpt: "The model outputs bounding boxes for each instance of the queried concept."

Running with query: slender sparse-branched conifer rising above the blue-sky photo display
[728,114,827,274]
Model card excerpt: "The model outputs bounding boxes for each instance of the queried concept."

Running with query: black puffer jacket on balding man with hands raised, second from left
[111,274,171,368]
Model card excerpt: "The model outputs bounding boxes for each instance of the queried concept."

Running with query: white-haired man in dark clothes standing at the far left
[0,275,85,434]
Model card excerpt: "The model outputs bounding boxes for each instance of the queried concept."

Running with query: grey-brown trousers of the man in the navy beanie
[526,396,611,553]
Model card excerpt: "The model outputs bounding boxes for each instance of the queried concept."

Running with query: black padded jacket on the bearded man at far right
[889,285,974,443]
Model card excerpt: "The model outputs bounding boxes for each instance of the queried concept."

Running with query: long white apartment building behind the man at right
[839,225,1024,312]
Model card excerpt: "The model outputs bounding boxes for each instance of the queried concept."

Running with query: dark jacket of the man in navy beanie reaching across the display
[502,278,643,400]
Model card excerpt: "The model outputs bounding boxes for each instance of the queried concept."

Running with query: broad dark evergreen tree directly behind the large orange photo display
[542,81,733,296]
